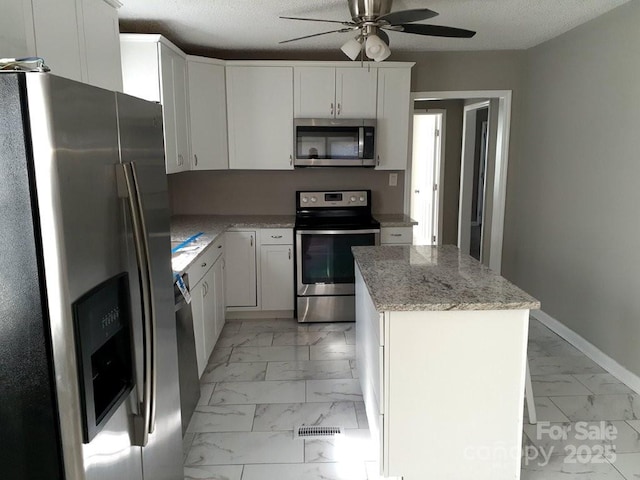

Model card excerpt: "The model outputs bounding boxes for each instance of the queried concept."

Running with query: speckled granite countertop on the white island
[352,245,540,312]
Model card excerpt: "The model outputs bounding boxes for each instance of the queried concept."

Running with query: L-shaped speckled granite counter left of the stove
[171,215,295,273]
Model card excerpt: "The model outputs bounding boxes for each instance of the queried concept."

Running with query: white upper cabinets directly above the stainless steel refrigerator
[0,0,122,90]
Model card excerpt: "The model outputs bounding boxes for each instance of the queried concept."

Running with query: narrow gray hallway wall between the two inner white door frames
[415,100,464,245]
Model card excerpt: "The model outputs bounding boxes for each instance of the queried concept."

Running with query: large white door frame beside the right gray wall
[404,90,512,273]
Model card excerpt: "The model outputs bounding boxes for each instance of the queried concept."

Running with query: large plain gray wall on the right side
[503,1,640,375]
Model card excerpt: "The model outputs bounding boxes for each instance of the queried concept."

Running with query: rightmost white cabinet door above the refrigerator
[82,0,122,92]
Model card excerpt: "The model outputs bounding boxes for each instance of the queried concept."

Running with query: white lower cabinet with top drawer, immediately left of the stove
[260,229,293,310]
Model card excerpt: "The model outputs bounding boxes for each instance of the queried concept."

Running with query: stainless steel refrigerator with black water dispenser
[0,73,183,480]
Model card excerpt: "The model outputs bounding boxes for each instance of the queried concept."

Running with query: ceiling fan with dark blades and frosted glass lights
[280,0,476,62]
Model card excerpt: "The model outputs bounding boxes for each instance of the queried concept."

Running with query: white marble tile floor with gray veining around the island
[184,319,640,480]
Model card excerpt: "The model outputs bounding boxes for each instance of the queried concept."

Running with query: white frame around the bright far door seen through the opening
[407,108,447,245]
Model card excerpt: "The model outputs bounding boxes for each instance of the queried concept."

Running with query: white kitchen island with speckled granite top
[353,246,540,480]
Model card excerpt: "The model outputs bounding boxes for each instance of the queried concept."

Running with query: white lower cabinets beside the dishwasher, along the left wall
[187,238,225,377]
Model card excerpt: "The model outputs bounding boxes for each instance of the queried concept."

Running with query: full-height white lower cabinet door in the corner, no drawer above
[225,231,258,307]
